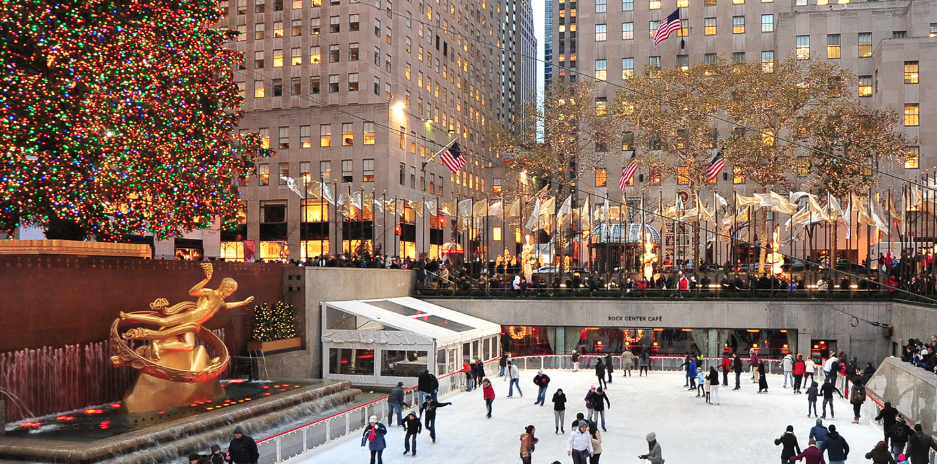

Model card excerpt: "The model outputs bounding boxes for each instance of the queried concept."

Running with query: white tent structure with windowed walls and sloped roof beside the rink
[321,297,501,385]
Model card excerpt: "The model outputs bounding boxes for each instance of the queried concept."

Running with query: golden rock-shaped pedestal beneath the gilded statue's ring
[121,374,225,413]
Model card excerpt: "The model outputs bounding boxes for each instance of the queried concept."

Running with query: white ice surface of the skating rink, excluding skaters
[293,370,882,464]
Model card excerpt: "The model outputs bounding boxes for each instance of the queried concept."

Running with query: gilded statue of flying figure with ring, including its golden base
[109,263,254,412]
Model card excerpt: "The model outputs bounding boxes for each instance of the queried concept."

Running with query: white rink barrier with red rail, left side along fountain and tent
[249,359,498,464]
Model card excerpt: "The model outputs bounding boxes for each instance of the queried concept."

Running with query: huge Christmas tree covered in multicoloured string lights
[0,0,270,240]
